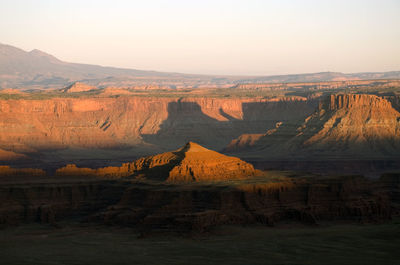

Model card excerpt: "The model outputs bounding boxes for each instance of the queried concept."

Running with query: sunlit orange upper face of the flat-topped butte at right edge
[303,94,400,152]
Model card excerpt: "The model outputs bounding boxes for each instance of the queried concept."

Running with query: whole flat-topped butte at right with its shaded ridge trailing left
[226,94,400,159]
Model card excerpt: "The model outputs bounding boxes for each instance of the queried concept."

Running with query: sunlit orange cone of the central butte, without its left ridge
[167,142,257,182]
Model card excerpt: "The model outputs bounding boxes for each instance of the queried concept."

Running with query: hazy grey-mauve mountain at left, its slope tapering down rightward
[0,44,168,88]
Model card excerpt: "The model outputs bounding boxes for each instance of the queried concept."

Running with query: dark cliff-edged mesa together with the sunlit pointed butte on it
[0,142,400,233]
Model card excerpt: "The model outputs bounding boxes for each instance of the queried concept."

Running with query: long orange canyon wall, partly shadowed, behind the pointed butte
[0,96,317,159]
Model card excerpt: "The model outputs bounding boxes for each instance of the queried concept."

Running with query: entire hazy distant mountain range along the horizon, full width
[0,44,400,88]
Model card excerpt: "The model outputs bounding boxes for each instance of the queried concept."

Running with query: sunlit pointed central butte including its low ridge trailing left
[56,142,261,182]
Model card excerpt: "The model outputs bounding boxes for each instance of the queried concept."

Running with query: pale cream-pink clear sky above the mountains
[0,0,400,75]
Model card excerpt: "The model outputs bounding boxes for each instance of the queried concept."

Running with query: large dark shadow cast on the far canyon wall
[142,100,316,150]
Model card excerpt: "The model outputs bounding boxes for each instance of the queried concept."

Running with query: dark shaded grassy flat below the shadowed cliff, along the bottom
[0,220,400,265]
